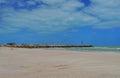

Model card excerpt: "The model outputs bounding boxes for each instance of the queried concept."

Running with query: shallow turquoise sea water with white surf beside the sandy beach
[64,47,120,52]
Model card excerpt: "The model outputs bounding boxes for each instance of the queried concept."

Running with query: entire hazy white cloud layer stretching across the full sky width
[0,0,120,33]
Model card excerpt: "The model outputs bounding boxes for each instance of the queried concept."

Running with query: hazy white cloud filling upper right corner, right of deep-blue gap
[84,0,120,28]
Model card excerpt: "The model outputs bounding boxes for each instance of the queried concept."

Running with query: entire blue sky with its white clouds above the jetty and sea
[0,0,120,46]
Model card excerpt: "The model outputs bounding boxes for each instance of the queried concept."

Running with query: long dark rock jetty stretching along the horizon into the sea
[0,43,93,48]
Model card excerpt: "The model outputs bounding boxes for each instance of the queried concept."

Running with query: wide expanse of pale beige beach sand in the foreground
[0,47,120,78]
